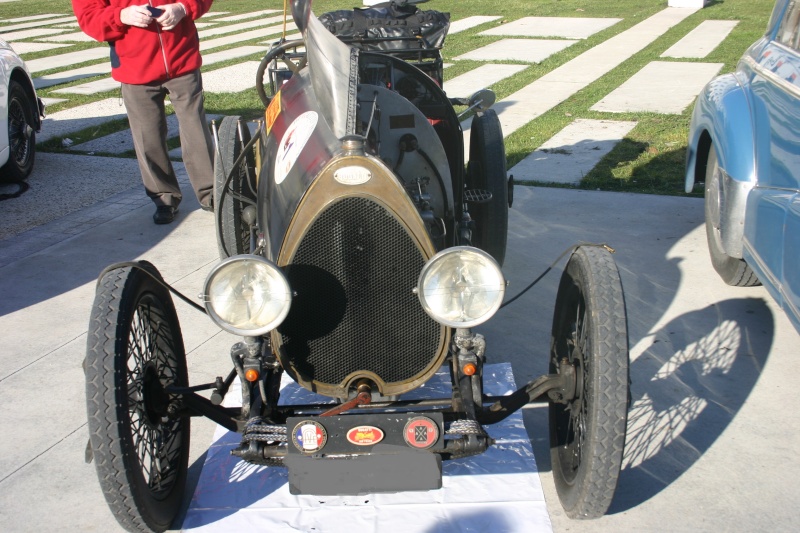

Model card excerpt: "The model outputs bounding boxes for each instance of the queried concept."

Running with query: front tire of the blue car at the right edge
[704,144,760,287]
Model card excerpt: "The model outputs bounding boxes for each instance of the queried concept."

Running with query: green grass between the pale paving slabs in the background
[0,0,774,195]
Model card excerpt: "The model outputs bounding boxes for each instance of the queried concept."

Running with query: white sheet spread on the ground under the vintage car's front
[183,363,552,533]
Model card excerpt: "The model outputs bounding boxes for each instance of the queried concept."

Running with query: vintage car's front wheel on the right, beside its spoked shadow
[549,247,629,518]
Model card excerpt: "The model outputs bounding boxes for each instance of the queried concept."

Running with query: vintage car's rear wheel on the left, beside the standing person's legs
[214,116,256,259]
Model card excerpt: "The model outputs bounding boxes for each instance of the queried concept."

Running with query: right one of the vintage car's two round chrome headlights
[417,246,506,328]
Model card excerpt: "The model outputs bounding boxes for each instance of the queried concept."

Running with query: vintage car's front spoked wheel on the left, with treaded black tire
[86,262,190,531]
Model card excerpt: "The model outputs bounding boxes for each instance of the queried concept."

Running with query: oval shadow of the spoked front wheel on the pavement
[609,298,774,514]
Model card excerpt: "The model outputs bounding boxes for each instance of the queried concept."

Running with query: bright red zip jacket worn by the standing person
[72,0,213,85]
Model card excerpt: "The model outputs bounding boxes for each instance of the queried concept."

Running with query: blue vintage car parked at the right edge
[686,0,800,331]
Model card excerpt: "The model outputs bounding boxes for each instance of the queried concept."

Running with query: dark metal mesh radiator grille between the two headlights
[279,198,441,384]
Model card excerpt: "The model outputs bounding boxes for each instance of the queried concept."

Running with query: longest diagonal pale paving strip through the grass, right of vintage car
[482,8,697,143]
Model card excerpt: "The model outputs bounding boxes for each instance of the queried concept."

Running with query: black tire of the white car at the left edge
[0,80,36,181]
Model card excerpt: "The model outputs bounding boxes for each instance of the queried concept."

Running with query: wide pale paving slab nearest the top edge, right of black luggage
[478,17,622,39]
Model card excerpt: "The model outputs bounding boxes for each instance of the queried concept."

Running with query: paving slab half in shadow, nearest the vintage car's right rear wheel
[508,119,636,185]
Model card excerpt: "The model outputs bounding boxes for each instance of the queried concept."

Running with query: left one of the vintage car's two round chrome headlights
[203,255,292,337]
